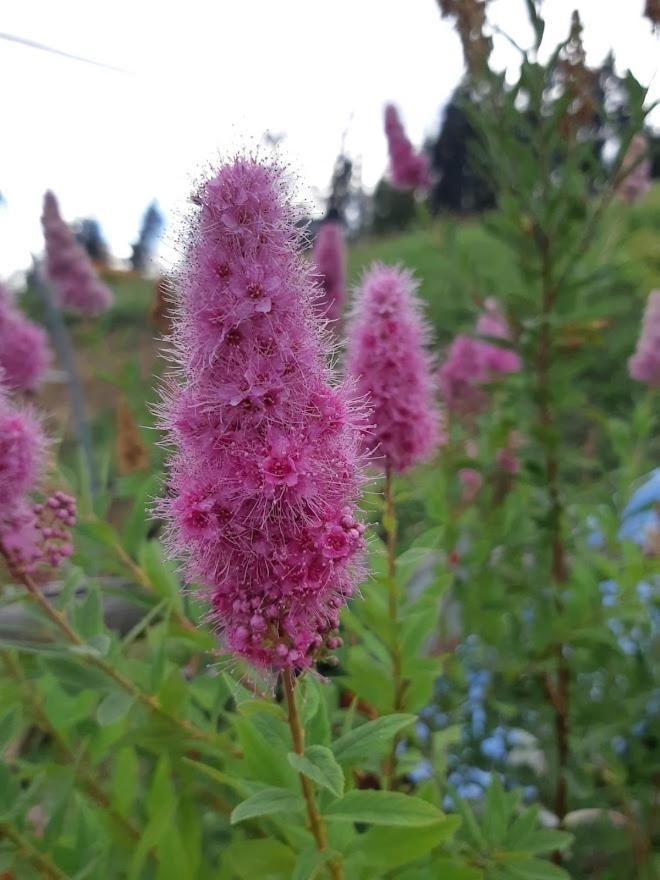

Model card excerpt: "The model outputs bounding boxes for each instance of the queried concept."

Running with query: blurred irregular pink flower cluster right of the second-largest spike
[440,297,521,414]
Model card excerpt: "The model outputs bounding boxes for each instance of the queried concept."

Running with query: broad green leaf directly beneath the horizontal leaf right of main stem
[351,816,461,876]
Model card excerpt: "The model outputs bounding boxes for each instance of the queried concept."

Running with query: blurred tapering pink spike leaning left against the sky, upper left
[41,192,112,316]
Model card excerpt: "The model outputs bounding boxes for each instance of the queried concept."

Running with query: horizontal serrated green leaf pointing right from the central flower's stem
[324,789,445,828]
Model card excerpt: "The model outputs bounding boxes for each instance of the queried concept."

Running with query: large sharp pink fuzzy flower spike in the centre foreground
[161,157,364,669]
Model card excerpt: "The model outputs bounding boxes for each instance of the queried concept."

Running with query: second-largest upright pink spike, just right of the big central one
[347,264,445,472]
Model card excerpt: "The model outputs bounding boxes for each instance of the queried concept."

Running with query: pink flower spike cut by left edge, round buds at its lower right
[0,383,76,576]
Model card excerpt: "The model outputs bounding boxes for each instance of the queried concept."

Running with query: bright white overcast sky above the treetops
[0,0,660,275]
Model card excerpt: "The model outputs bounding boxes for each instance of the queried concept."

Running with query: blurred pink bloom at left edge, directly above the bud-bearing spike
[0,284,51,391]
